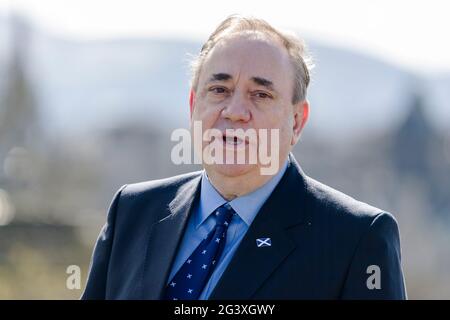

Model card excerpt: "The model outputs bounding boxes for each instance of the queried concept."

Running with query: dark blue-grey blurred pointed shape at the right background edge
[389,87,450,219]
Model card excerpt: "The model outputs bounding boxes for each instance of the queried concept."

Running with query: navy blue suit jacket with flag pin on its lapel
[82,155,406,300]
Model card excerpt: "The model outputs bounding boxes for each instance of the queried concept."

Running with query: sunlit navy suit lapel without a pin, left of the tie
[141,175,201,300]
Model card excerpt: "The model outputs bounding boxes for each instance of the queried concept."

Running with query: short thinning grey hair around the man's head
[191,15,313,104]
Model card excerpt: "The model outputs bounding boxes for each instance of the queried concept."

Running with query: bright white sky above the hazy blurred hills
[0,0,450,73]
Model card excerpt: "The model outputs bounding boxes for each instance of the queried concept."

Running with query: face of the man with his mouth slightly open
[191,34,308,181]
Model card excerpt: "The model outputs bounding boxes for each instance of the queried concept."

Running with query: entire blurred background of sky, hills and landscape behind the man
[0,0,450,299]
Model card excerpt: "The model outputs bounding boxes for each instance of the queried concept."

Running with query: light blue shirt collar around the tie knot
[195,160,288,228]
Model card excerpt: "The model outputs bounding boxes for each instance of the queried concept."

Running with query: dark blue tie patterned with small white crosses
[164,203,235,300]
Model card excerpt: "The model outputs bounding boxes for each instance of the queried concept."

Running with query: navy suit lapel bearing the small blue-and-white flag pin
[209,155,309,300]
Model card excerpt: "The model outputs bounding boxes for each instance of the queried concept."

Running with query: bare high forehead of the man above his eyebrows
[200,33,292,85]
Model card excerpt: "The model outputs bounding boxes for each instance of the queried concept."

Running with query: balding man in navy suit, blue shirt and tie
[82,16,406,300]
